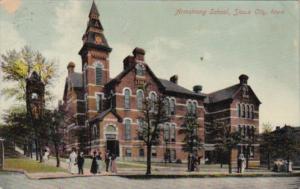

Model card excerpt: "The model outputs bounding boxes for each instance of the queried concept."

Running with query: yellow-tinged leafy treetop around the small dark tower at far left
[1,46,57,101]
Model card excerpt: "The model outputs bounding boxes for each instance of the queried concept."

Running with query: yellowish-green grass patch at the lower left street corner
[4,158,66,173]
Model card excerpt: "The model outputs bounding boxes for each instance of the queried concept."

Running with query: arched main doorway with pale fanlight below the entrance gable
[105,125,120,156]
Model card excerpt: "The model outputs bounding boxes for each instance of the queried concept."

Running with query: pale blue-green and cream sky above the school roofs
[0,0,300,129]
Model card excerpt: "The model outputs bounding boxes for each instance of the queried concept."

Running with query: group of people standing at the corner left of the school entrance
[68,149,117,175]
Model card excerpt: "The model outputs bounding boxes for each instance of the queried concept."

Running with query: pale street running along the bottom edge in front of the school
[0,173,300,189]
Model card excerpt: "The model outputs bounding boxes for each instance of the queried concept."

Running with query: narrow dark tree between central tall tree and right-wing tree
[179,112,202,171]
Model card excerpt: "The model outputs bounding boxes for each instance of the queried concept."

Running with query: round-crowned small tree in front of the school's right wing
[207,121,241,173]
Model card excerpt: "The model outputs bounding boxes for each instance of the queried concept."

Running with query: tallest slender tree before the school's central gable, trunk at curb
[138,95,169,175]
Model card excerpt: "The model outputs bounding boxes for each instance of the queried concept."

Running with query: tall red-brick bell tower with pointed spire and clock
[79,1,112,118]
